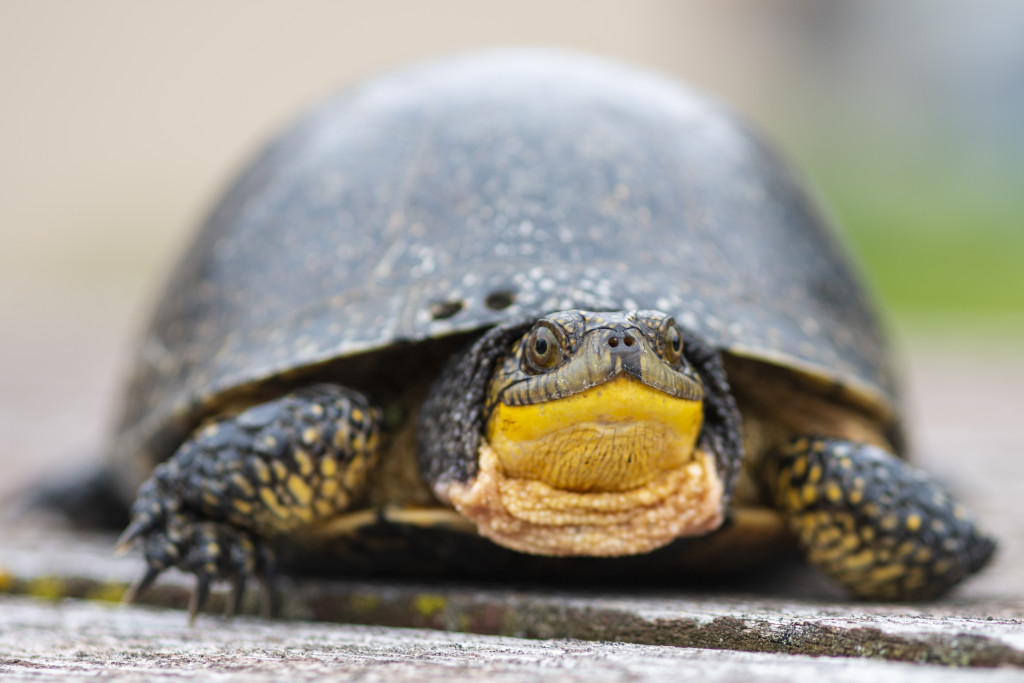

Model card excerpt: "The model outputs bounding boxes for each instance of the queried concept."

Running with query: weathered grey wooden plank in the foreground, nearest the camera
[6,598,1024,683]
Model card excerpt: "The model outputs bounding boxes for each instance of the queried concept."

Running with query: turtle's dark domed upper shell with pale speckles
[114,50,895,491]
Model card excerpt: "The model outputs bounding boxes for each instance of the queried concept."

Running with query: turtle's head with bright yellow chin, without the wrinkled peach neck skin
[484,311,703,494]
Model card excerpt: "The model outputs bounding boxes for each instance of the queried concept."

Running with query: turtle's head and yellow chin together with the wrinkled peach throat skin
[447,310,724,555]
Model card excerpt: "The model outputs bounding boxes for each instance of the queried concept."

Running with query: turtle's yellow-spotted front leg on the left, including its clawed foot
[118,384,381,618]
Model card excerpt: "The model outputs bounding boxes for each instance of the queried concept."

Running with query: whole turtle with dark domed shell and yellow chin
[111,49,995,616]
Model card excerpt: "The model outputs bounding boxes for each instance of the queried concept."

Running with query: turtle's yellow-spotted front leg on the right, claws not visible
[764,437,995,600]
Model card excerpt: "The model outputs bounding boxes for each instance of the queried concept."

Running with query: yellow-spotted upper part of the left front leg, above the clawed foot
[126,385,380,538]
